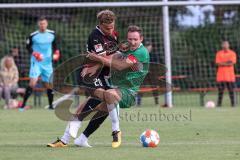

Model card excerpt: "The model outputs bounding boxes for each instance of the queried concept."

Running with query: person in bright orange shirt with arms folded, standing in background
[216,41,237,107]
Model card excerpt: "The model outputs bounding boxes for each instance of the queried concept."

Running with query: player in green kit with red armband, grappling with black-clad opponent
[82,26,149,148]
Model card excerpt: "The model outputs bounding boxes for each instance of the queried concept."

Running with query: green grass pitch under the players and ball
[0,96,240,160]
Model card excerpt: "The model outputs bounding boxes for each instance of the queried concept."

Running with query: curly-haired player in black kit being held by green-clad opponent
[47,10,121,147]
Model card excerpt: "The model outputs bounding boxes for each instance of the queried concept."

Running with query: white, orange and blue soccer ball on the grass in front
[140,129,160,148]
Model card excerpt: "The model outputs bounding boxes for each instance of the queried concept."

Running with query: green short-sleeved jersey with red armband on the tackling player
[110,44,149,93]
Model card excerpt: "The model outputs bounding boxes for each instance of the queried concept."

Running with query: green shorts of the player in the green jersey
[119,88,135,108]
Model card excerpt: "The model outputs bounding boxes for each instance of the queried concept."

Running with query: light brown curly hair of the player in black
[97,9,116,24]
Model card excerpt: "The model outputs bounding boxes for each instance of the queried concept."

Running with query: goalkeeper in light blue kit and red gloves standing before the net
[19,17,60,111]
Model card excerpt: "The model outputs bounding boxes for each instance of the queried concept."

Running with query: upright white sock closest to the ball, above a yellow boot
[107,104,120,131]
